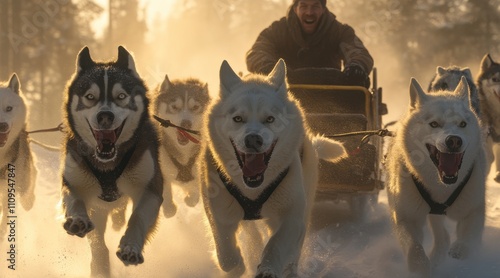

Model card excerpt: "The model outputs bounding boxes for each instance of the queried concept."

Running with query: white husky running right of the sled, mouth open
[386,77,486,277]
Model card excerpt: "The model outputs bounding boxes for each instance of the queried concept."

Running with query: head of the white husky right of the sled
[401,77,481,185]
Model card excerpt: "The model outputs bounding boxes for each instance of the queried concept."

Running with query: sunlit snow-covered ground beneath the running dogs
[0,138,500,278]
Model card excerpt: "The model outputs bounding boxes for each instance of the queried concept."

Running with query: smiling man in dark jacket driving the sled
[246,0,373,88]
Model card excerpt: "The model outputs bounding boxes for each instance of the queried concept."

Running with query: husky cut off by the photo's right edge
[476,54,500,183]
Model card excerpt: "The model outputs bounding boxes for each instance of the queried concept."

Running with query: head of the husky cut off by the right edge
[477,54,500,103]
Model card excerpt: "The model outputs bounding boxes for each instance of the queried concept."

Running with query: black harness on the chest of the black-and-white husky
[83,146,135,202]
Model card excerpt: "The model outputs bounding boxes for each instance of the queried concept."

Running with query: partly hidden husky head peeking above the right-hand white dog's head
[428,66,475,92]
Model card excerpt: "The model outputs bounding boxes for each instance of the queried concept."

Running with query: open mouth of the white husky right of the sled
[426,144,464,184]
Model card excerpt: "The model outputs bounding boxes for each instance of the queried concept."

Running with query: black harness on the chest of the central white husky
[217,164,289,220]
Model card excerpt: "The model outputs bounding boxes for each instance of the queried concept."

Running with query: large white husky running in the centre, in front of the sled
[199,59,345,277]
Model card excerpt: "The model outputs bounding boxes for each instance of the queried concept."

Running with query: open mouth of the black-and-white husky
[89,121,125,161]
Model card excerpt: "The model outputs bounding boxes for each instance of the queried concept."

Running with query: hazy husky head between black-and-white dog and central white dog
[153,75,210,148]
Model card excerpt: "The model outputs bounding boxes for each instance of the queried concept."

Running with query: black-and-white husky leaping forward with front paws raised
[61,46,163,277]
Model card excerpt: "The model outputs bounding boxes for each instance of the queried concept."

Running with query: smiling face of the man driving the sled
[293,0,325,34]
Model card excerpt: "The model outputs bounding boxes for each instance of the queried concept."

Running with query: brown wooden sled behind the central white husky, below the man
[288,68,387,217]
